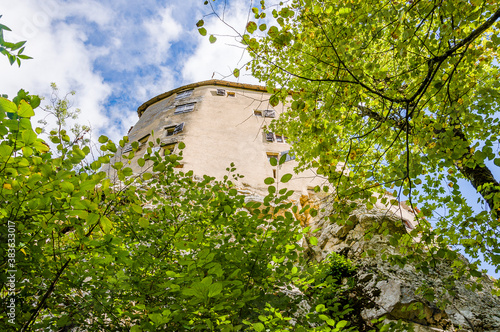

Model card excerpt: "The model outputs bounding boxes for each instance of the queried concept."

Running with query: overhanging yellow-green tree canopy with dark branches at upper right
[201,0,500,288]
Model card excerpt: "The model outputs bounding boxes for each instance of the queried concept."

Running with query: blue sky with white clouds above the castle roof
[0,0,258,140]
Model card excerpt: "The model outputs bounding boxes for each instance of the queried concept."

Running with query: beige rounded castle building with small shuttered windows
[117,80,324,193]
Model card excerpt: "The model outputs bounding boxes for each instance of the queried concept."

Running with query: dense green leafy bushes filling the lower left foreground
[0,90,358,331]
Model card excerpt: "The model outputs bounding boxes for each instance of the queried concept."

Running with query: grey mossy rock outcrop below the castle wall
[242,188,500,332]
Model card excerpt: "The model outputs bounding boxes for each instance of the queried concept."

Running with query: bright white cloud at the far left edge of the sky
[0,1,110,137]
